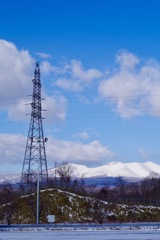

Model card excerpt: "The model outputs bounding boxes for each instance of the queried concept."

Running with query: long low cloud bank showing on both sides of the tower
[0,134,115,172]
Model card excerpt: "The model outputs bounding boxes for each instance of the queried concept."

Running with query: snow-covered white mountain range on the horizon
[0,162,160,183]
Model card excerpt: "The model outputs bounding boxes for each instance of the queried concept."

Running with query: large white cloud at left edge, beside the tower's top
[0,40,34,98]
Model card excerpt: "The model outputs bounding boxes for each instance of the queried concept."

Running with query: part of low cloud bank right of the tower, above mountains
[46,137,115,166]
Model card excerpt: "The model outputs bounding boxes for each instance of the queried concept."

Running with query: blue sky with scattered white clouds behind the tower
[0,0,160,174]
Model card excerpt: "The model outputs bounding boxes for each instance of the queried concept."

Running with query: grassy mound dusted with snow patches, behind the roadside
[0,189,160,224]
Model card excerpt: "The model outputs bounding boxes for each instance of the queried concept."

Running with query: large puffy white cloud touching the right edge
[99,51,160,118]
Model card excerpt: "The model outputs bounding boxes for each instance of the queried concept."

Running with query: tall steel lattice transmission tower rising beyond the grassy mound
[21,62,48,184]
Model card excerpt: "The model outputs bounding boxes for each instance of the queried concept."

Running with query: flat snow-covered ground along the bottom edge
[0,230,160,240]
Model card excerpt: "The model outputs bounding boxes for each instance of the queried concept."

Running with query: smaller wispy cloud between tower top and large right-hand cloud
[54,60,102,92]
